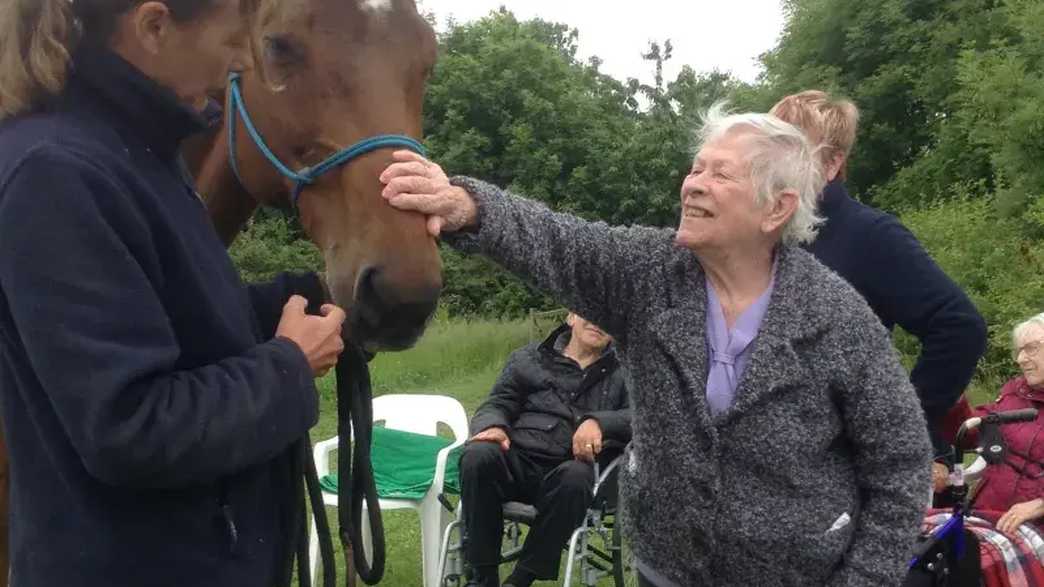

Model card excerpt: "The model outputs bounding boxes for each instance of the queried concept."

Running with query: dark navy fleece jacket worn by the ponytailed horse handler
[0,51,322,587]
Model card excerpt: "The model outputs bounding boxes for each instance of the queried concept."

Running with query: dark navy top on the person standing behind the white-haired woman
[809,181,987,454]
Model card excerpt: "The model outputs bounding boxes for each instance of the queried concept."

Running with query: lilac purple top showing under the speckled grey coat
[707,262,776,416]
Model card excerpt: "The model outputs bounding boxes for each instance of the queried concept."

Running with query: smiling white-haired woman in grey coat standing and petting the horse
[381,109,930,587]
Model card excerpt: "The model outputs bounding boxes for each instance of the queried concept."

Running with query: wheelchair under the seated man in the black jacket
[438,447,638,587]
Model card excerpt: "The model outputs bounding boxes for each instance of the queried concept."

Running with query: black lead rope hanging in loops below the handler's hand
[280,345,384,587]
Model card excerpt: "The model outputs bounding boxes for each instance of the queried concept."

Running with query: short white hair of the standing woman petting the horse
[696,102,826,244]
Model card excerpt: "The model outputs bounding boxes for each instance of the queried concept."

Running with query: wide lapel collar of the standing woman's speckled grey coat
[650,245,834,428]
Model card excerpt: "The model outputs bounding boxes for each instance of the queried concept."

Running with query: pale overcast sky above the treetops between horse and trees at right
[418,0,783,81]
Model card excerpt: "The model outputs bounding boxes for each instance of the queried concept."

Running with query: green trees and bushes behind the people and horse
[233,0,1044,388]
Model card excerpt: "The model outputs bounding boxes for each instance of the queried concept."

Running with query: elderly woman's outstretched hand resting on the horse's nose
[380,150,478,236]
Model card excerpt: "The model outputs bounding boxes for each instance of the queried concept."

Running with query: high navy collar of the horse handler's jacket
[65,46,208,158]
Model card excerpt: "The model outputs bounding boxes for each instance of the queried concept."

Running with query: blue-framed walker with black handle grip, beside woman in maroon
[903,408,1037,587]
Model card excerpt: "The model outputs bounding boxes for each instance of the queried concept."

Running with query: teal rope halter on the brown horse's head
[229,73,426,206]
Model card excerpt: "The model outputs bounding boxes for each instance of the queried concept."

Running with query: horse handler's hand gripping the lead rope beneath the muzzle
[276,296,346,377]
